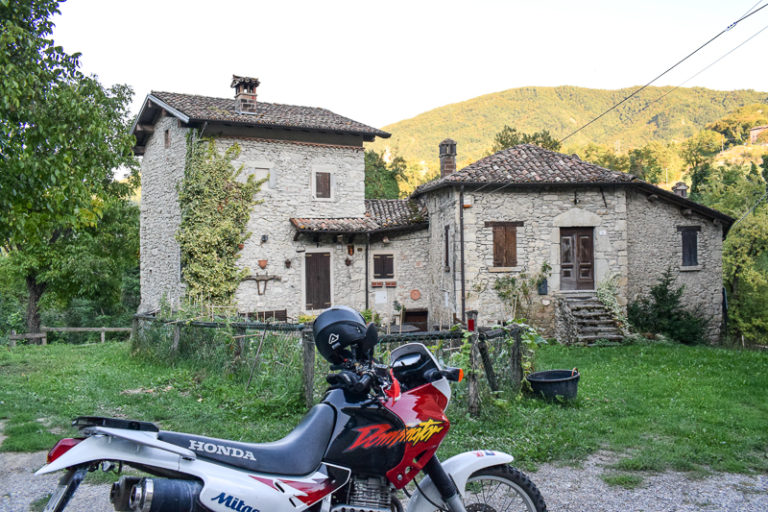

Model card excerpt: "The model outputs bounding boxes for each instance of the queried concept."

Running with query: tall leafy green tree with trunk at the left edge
[0,0,135,332]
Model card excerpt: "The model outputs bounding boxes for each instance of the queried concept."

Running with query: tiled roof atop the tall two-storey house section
[131,91,390,150]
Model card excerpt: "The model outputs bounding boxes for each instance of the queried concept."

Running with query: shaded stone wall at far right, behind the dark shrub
[627,191,723,341]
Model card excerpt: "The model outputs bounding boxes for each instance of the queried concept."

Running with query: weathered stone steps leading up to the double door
[555,291,624,345]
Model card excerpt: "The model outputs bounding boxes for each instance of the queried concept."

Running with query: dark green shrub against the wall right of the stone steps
[627,268,708,344]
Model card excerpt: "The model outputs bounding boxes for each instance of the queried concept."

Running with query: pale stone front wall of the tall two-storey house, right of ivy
[222,138,365,318]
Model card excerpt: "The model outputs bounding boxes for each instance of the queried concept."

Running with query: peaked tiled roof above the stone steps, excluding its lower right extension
[414,144,637,195]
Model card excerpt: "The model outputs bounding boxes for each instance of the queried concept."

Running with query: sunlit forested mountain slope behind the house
[368,86,768,169]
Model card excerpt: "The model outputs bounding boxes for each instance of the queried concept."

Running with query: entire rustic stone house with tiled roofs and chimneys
[133,77,733,337]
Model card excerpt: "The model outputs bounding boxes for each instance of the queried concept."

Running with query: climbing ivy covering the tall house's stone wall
[176,135,263,305]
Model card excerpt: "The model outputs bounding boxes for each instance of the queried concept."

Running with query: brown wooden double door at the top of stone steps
[560,228,595,290]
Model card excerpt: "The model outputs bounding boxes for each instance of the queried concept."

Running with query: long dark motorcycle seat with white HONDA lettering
[157,404,335,476]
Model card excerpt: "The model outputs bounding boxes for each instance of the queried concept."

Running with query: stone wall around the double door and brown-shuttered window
[426,187,627,335]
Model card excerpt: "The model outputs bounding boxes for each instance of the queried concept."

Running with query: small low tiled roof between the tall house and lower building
[291,199,428,235]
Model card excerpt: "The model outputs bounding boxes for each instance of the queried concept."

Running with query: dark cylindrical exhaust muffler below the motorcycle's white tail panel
[121,477,204,512]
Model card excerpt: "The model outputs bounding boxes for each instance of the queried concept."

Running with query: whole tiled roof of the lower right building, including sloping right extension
[411,144,735,229]
